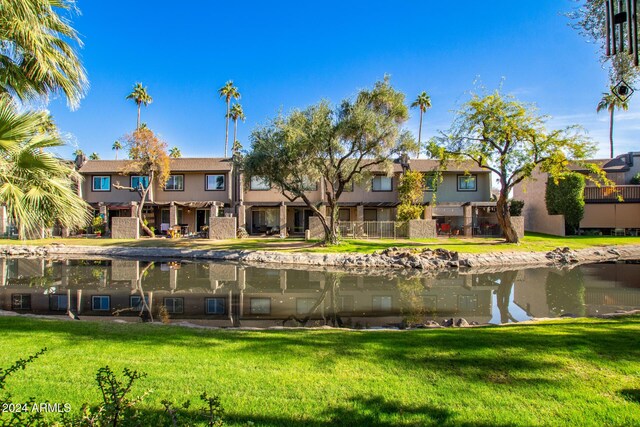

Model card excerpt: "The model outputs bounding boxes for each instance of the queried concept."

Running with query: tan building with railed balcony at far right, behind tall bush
[514,152,640,236]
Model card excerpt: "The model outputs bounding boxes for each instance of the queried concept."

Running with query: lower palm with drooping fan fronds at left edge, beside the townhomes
[0,96,90,238]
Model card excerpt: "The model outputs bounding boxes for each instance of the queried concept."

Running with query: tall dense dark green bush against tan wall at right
[544,172,585,233]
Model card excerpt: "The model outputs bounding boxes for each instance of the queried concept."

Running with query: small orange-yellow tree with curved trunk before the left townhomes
[114,128,171,237]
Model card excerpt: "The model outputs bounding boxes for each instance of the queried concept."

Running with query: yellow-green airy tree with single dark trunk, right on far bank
[429,91,607,243]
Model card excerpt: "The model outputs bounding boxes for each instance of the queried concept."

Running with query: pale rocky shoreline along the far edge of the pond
[0,243,640,271]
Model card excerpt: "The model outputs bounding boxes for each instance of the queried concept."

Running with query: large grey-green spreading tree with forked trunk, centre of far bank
[241,77,416,244]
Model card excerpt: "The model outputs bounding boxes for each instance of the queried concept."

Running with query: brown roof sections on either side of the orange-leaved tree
[79,157,232,174]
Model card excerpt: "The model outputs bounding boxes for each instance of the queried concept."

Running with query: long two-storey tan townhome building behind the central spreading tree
[76,158,499,239]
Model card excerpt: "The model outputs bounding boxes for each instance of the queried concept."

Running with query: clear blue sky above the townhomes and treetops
[49,0,640,159]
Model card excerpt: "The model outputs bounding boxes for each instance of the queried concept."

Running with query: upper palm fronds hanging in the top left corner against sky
[0,0,88,109]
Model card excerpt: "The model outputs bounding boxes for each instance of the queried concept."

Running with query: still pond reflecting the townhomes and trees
[0,258,640,328]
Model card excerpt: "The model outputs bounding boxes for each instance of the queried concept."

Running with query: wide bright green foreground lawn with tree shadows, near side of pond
[0,317,640,426]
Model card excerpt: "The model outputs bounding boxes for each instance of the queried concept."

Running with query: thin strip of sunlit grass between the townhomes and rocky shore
[0,233,640,253]
